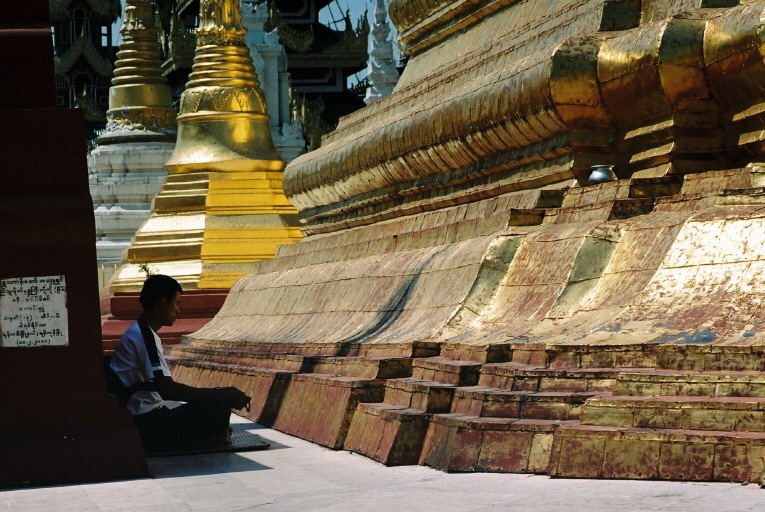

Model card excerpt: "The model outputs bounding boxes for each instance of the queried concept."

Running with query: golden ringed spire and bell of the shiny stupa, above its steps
[166,0,284,173]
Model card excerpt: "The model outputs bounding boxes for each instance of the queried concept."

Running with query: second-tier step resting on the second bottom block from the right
[451,386,597,420]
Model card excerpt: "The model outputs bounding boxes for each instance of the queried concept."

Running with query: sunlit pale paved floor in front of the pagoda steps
[0,416,765,512]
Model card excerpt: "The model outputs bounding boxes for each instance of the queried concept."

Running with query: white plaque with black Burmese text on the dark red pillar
[0,276,69,348]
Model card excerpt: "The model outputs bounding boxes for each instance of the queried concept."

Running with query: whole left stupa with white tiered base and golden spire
[88,0,176,292]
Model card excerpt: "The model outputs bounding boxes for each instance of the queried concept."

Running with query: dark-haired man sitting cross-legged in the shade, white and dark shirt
[110,274,250,452]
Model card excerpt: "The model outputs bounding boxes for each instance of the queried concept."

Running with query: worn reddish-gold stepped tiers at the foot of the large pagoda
[169,338,765,482]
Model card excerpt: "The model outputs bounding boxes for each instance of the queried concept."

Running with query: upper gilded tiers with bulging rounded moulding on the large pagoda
[285,0,762,234]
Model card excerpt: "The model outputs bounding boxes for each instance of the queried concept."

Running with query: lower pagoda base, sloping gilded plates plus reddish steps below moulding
[167,169,765,482]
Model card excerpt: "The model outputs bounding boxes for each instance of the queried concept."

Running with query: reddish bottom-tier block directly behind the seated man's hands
[167,357,295,427]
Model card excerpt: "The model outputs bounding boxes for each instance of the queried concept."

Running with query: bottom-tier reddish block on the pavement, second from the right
[419,414,573,473]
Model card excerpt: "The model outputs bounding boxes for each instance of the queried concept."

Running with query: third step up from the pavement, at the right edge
[613,368,765,397]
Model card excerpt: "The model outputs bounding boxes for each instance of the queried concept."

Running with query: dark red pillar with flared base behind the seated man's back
[0,0,147,487]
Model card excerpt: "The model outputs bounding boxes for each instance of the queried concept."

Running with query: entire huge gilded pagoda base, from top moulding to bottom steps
[168,0,765,482]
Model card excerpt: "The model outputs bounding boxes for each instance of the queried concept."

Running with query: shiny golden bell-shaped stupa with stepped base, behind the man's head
[111,0,301,292]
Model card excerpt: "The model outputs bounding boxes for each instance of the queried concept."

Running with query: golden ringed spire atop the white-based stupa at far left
[98,0,176,143]
